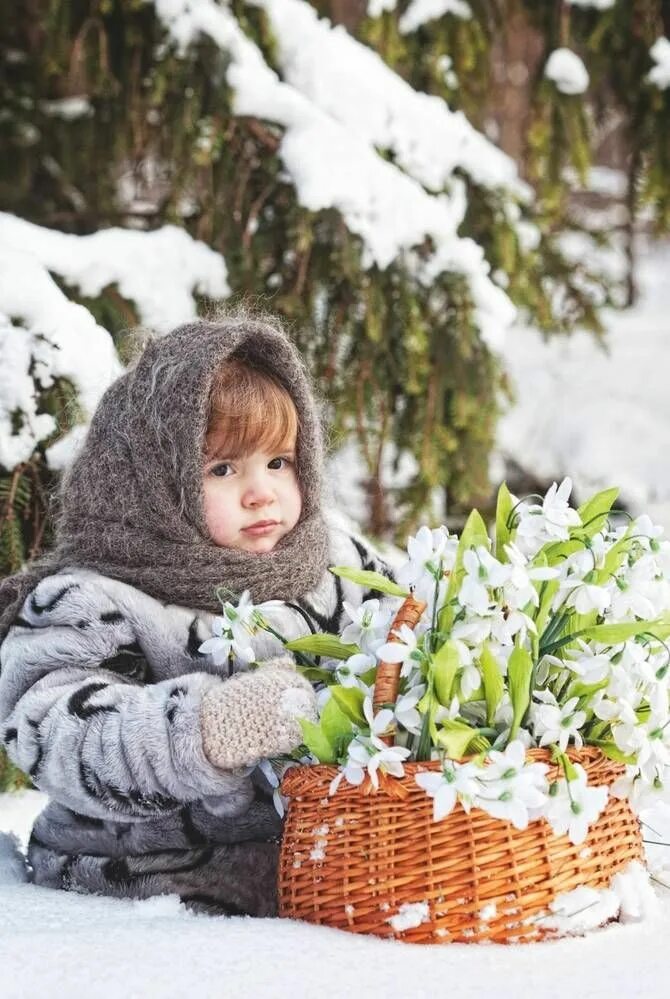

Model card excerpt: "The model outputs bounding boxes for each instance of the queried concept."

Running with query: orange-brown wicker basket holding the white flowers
[279,605,643,943]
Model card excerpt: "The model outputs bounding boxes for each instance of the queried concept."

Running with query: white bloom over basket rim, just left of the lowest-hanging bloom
[475,739,548,829]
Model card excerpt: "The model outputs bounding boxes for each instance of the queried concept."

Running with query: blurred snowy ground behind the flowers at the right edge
[498,243,670,531]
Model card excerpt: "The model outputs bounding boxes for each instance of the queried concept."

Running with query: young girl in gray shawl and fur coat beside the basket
[0,316,388,915]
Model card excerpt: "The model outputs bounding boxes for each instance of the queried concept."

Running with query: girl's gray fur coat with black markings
[0,528,390,915]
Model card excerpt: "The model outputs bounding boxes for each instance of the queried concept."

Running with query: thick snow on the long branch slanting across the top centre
[154,0,524,348]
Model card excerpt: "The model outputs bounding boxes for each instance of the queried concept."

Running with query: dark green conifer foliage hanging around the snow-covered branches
[0,0,670,556]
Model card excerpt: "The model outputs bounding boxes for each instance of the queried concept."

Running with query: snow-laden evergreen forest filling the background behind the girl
[0,0,670,786]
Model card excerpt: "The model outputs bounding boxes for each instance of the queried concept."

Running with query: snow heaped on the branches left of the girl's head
[0,213,228,470]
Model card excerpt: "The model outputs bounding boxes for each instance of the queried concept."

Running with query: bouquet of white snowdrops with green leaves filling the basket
[203,479,670,843]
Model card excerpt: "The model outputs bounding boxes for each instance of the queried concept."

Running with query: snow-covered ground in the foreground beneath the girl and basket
[0,792,670,999]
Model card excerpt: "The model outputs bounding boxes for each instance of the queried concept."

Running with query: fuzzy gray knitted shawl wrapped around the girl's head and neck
[0,316,328,641]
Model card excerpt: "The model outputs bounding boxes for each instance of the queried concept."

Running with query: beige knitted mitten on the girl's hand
[200,657,317,770]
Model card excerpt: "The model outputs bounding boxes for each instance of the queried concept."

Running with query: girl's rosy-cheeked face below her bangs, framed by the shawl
[203,449,302,555]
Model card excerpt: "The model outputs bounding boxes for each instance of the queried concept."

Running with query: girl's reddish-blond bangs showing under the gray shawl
[205,358,298,458]
